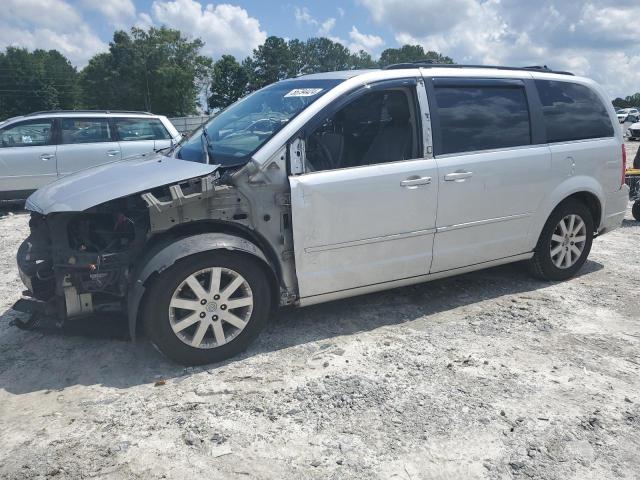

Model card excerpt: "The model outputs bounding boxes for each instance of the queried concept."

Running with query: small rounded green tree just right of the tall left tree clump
[208,55,249,108]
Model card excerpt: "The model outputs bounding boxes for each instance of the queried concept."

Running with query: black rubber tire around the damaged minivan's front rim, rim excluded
[142,251,272,365]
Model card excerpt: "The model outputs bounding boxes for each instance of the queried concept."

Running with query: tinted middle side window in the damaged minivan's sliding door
[435,86,531,154]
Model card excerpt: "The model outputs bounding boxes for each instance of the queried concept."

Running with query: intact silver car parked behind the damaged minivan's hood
[0,110,181,200]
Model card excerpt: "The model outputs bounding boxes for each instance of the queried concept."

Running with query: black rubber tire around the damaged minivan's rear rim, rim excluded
[529,199,594,281]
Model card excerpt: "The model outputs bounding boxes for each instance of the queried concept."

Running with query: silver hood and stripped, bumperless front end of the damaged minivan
[14,155,225,326]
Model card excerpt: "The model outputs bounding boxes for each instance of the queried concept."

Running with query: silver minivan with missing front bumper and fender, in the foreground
[14,63,629,364]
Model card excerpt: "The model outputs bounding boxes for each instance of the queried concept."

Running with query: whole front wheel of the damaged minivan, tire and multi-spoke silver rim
[143,251,271,365]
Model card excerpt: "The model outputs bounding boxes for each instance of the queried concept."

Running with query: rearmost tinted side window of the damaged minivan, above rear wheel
[536,80,613,143]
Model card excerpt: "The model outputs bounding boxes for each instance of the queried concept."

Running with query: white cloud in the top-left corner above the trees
[0,0,107,67]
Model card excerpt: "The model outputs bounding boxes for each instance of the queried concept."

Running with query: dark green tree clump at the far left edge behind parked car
[0,47,78,119]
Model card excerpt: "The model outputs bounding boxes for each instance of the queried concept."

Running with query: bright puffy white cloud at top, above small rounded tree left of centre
[151,0,267,57]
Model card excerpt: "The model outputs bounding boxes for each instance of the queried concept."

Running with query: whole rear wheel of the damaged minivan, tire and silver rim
[529,200,594,280]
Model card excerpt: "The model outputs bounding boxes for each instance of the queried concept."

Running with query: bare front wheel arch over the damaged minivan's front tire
[127,232,279,340]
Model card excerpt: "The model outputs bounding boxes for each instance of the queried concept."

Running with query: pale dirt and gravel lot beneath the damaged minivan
[0,157,640,480]
